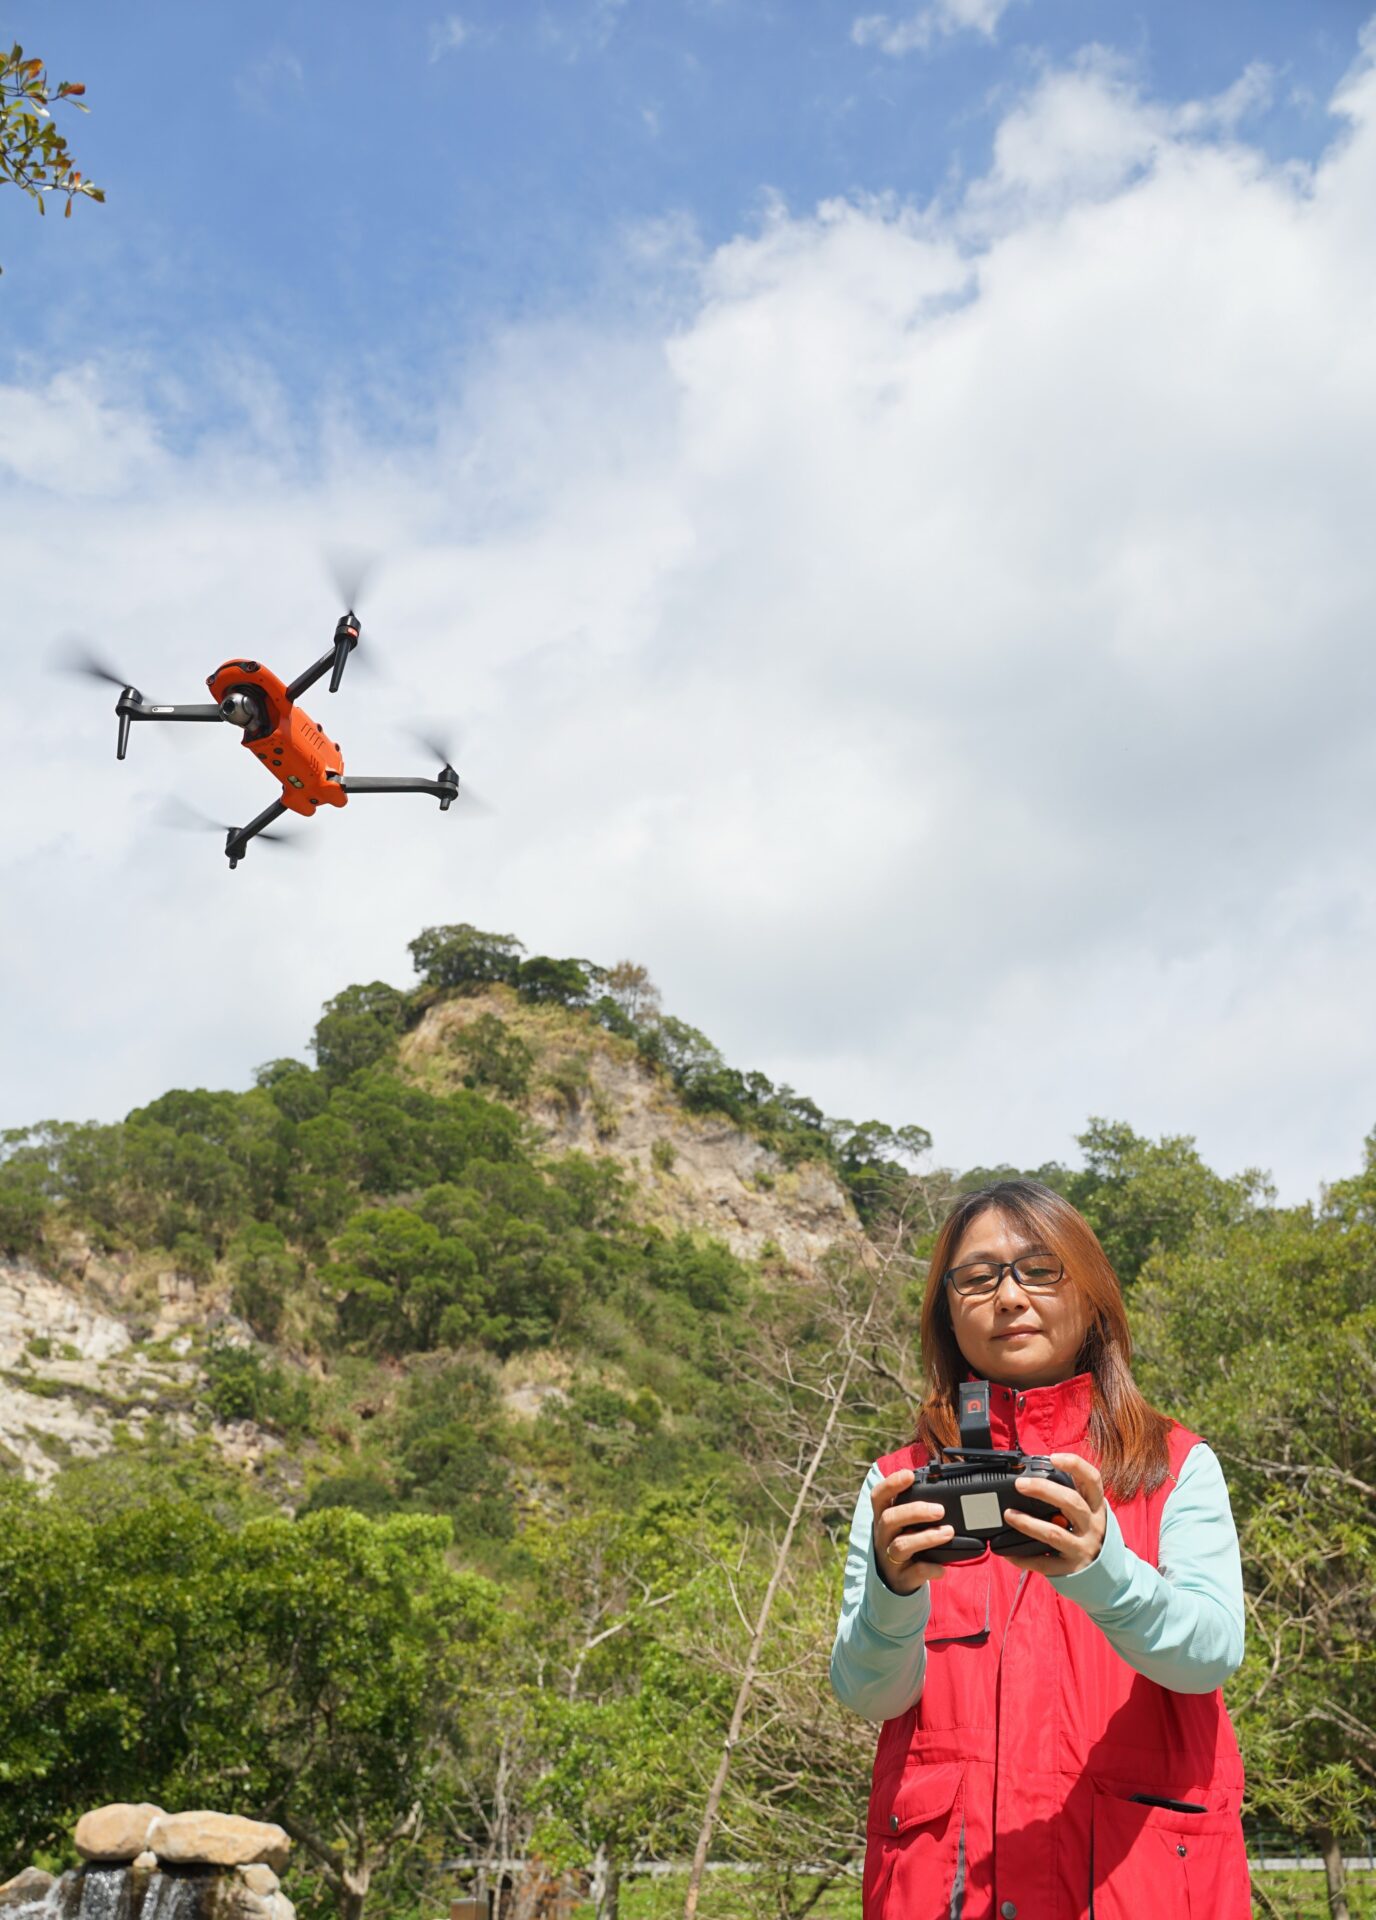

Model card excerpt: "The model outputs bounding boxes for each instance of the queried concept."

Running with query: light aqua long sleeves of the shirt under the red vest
[831,1444,1244,1720]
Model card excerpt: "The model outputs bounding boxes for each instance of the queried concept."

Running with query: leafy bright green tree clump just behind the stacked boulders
[0,1486,497,1920]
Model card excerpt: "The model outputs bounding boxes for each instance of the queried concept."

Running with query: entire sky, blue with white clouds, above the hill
[0,0,1376,1196]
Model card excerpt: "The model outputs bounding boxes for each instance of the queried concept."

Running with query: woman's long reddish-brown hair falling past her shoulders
[913,1181,1171,1500]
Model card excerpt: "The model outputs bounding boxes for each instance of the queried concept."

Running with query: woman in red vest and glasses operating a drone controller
[831,1181,1251,1920]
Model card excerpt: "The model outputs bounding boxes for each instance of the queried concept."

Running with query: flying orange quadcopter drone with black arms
[75,611,459,868]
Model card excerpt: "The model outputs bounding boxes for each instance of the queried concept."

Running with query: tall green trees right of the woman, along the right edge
[1134,1182,1376,1916]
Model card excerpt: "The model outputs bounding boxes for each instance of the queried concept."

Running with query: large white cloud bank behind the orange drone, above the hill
[0,30,1376,1192]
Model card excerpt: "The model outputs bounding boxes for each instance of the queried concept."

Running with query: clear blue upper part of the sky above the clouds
[0,0,1364,409]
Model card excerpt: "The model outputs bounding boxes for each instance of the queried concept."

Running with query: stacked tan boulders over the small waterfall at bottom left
[0,1803,296,1920]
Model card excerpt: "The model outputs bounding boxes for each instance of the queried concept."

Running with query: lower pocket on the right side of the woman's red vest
[1090,1789,1251,1920]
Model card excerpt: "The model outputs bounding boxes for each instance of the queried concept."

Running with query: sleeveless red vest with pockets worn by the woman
[864,1375,1251,1920]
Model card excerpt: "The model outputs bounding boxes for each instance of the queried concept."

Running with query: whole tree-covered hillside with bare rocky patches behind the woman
[0,925,1376,1920]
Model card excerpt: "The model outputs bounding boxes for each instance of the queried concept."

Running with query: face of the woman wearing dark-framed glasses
[946,1208,1088,1386]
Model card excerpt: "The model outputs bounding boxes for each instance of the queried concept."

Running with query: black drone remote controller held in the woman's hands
[902,1380,1075,1565]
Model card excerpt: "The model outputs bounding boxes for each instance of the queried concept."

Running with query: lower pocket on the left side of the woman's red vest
[864,1758,965,1920]
